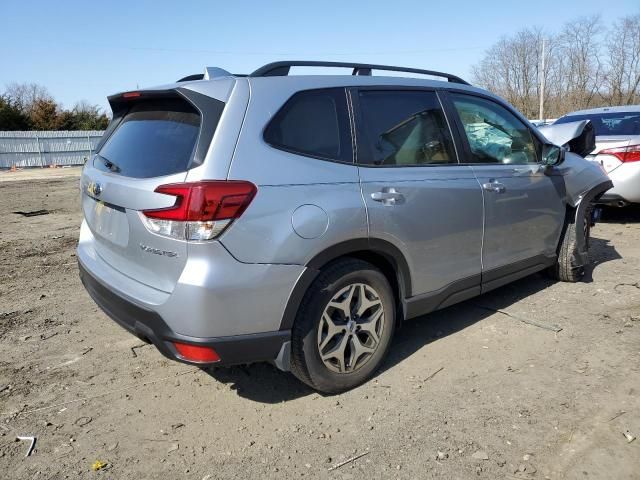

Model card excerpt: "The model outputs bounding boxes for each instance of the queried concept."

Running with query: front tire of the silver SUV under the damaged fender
[548,207,592,283]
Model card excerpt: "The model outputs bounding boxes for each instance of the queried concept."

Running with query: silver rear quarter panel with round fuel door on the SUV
[221,78,367,265]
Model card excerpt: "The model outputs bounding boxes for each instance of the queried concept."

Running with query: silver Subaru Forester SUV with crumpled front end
[78,62,611,393]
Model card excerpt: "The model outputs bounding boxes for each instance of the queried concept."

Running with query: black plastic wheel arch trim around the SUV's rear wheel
[280,238,411,330]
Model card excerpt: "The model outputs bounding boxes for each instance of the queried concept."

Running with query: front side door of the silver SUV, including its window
[448,92,566,290]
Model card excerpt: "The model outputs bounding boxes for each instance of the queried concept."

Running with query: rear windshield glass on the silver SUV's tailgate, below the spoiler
[93,99,200,178]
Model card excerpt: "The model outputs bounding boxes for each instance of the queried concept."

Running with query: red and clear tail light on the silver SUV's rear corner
[141,180,257,240]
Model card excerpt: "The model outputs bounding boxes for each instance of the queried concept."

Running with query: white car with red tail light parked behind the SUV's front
[554,105,640,207]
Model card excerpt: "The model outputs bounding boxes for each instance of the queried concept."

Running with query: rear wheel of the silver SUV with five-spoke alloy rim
[291,258,396,393]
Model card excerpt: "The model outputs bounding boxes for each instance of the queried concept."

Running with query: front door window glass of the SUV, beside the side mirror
[451,94,541,164]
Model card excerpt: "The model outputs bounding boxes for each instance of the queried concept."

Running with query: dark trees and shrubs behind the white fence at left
[0,83,109,131]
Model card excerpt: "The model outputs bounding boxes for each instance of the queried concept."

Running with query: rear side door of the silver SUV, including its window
[350,87,482,306]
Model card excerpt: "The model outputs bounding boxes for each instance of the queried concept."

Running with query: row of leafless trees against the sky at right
[473,14,640,118]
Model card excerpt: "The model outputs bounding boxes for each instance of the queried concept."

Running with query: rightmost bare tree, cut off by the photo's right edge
[606,15,640,105]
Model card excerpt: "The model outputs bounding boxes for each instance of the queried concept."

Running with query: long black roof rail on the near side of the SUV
[249,60,471,85]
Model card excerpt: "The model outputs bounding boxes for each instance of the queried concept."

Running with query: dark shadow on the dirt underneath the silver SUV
[204,238,621,403]
